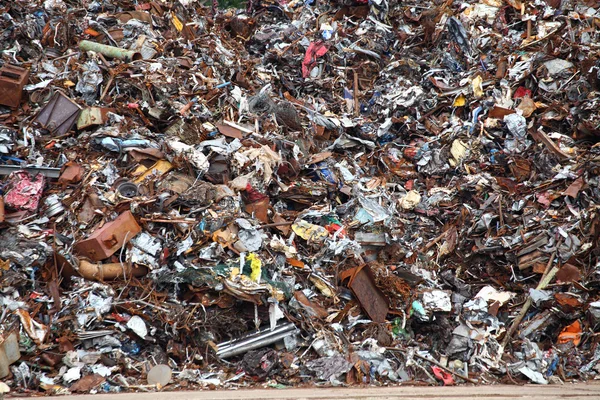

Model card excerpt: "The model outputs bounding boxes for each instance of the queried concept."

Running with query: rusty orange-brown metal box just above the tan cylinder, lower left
[75,211,142,261]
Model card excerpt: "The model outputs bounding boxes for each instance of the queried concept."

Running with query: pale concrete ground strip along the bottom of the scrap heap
[30,383,600,400]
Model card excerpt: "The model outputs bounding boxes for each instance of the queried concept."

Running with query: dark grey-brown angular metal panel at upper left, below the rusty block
[35,92,81,135]
